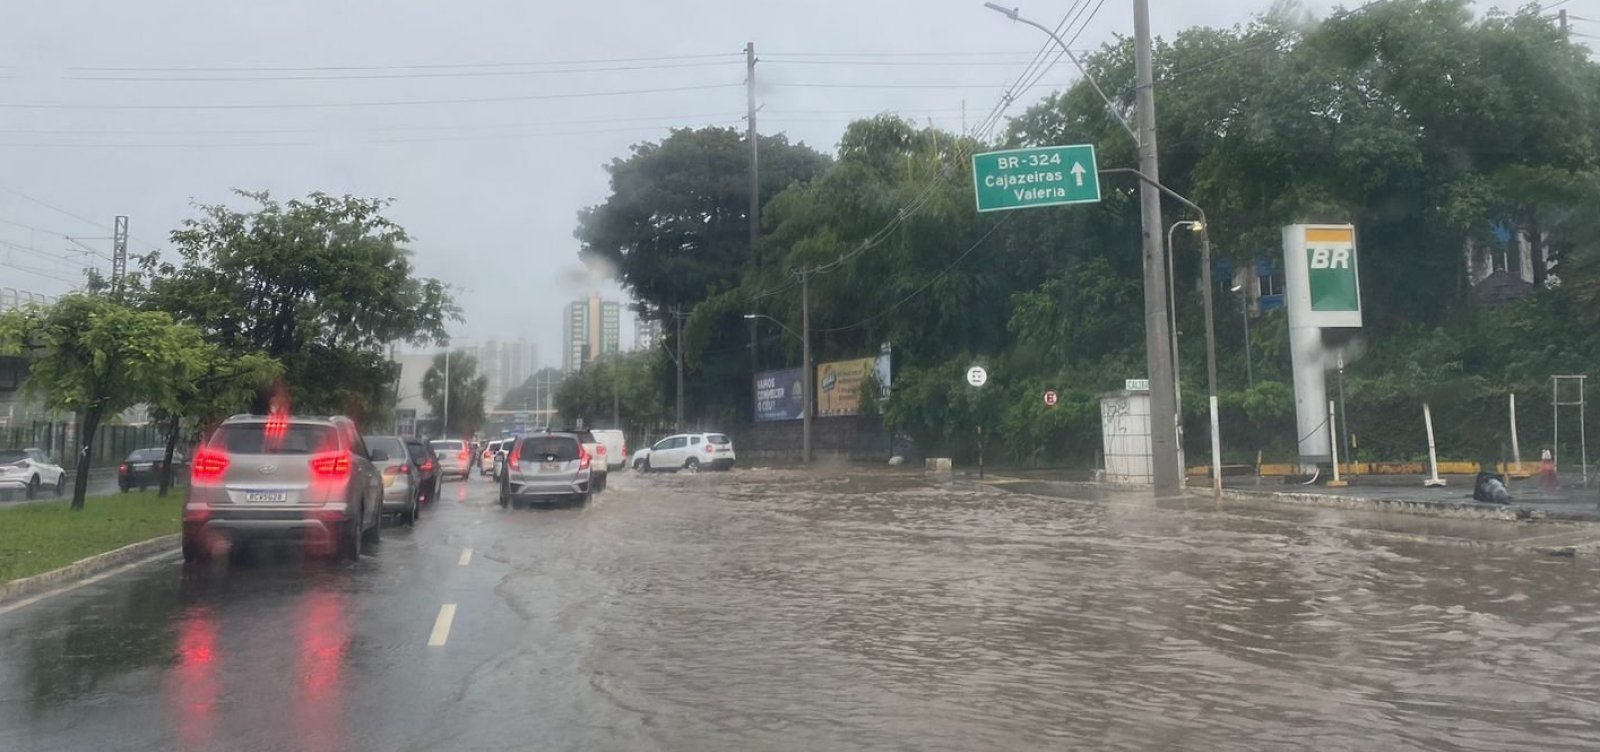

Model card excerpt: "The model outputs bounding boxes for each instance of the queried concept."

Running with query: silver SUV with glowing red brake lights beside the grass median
[182,416,389,562]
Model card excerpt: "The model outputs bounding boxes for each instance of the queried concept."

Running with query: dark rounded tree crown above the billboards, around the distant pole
[574,128,827,318]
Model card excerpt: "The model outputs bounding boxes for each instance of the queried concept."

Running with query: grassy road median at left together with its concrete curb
[0,491,182,602]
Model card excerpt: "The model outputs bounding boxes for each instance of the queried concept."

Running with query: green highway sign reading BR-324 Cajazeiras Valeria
[973,144,1099,211]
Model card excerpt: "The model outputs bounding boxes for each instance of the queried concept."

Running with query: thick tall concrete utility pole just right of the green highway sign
[1133,0,1182,496]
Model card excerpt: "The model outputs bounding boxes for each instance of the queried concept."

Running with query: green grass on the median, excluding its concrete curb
[0,491,184,582]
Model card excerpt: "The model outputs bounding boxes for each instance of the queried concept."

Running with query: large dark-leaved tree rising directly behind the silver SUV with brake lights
[130,190,459,416]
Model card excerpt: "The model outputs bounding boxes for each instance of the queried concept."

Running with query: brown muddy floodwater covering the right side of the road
[512,472,1600,750]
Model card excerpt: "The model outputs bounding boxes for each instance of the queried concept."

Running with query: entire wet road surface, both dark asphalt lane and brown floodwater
[0,470,1600,750]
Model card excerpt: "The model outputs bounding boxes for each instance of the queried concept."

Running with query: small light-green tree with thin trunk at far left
[0,294,206,509]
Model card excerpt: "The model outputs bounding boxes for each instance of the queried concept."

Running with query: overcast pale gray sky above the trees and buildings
[0,0,1363,365]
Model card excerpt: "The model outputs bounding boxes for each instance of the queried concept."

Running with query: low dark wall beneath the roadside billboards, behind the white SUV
[728,416,922,466]
